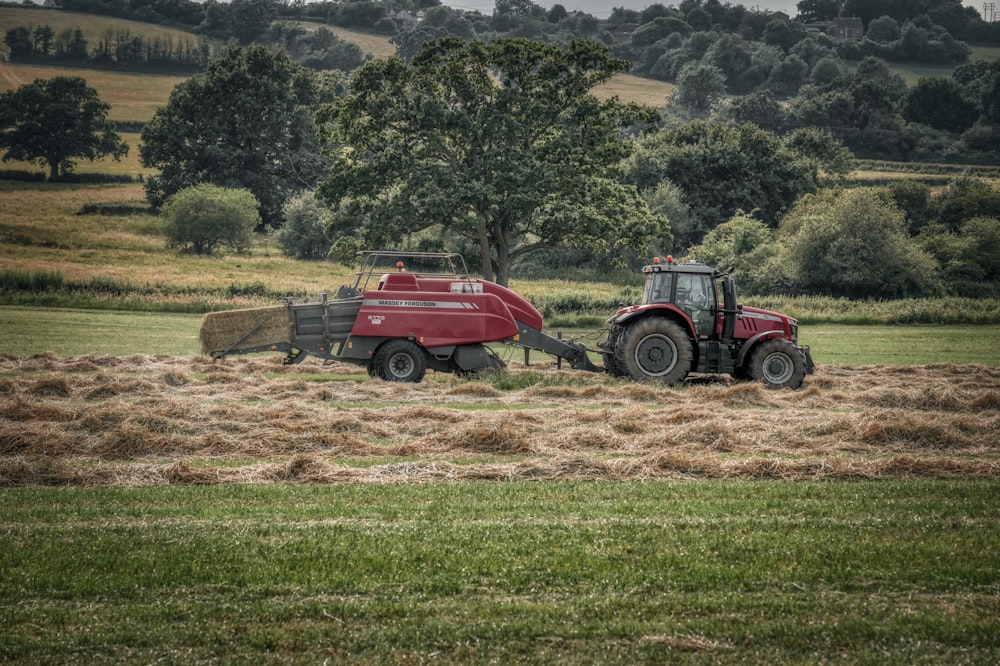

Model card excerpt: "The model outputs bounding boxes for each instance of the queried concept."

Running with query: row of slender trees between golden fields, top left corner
[4,24,214,71]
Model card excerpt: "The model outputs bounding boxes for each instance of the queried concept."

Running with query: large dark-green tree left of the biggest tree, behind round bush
[139,46,325,224]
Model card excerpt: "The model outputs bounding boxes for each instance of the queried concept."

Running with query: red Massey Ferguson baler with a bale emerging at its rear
[200,252,603,382]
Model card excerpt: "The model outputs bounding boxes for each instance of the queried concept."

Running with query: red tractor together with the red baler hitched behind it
[200,252,813,389]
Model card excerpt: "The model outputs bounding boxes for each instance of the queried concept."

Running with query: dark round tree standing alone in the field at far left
[0,76,128,180]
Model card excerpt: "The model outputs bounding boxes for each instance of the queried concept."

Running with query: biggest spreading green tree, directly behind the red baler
[320,38,664,284]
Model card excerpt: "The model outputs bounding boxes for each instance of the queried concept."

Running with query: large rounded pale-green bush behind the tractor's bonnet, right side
[782,190,941,298]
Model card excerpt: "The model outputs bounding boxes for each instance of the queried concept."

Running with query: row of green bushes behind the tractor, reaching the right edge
[691,176,1000,299]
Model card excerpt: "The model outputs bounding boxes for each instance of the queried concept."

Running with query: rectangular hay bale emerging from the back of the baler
[198,305,292,354]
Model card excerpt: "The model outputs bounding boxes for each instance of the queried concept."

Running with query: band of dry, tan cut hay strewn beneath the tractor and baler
[0,355,1000,486]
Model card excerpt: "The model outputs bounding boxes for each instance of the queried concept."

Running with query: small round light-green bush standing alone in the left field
[161,184,260,254]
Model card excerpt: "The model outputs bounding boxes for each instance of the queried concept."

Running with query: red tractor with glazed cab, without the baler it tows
[601,257,814,389]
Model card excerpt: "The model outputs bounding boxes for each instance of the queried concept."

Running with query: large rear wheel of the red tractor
[615,317,694,386]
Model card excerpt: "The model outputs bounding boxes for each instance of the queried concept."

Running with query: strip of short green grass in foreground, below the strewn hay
[0,481,1000,664]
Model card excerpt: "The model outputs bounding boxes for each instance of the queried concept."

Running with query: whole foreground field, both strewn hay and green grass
[0,353,1000,664]
